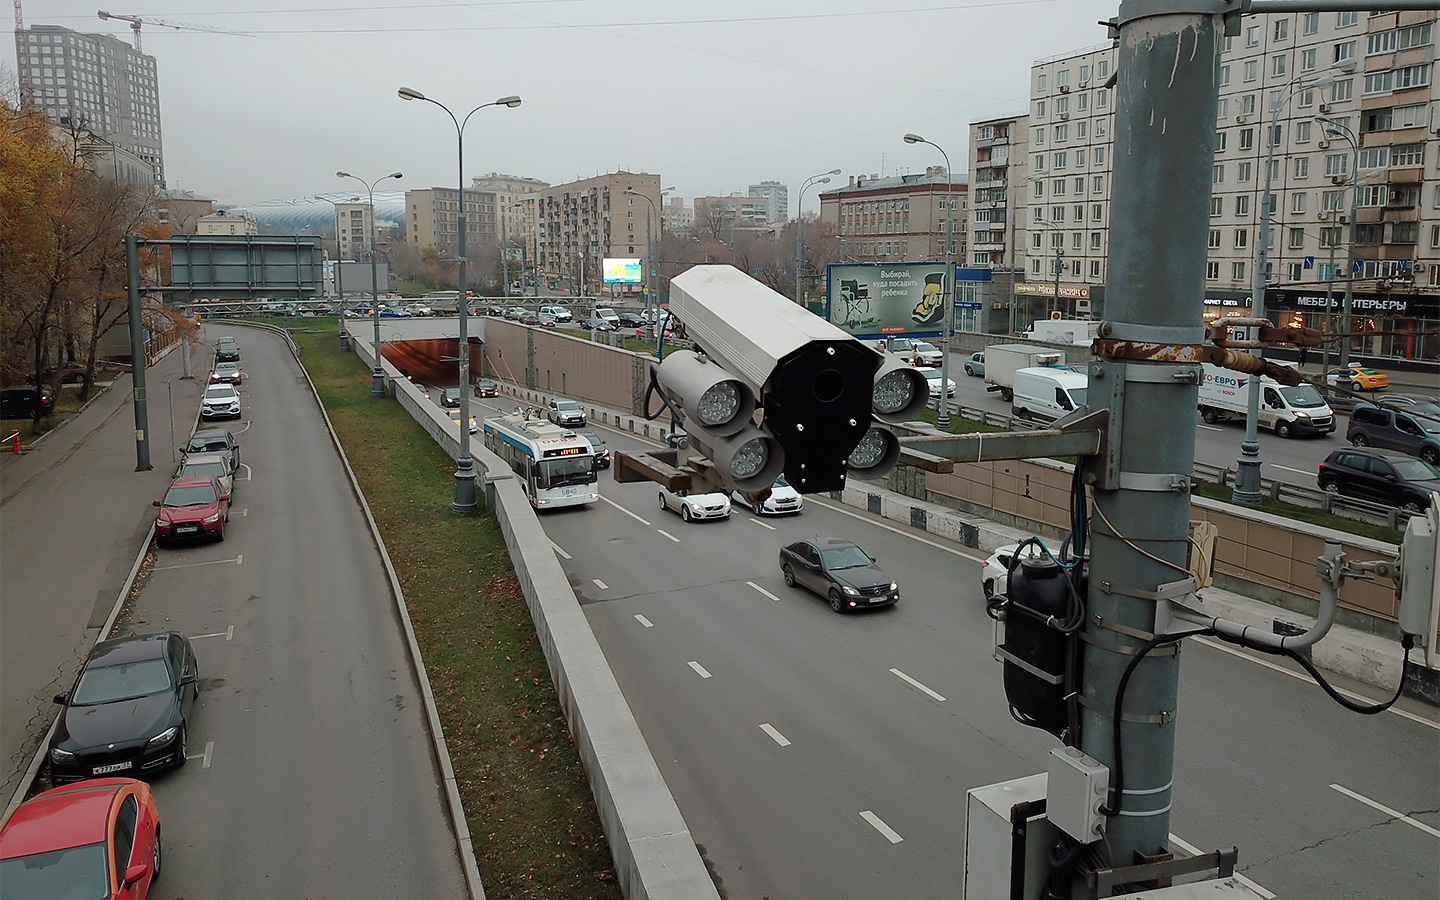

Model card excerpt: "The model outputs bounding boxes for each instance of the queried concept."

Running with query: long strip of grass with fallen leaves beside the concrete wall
[295,333,621,900]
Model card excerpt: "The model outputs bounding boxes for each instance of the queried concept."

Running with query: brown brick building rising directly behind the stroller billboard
[819,166,969,265]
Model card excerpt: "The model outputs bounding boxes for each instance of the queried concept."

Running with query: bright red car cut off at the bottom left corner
[0,778,160,900]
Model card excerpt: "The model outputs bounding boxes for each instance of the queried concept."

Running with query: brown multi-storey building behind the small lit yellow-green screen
[536,171,661,295]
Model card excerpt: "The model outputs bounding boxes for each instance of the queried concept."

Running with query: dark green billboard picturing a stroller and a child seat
[825,262,953,338]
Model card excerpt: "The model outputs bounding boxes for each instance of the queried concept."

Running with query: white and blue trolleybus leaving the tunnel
[485,409,600,510]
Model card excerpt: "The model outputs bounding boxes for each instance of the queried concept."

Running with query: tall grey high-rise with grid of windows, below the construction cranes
[14,24,166,187]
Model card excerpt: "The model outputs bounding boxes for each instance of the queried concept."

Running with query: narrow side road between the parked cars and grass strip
[137,326,464,896]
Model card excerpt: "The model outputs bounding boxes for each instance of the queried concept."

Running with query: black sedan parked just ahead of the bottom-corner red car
[48,631,200,785]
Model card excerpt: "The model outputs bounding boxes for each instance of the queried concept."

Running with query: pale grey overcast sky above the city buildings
[0,0,1119,208]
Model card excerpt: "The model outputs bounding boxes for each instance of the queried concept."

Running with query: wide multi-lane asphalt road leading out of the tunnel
[518,411,1440,900]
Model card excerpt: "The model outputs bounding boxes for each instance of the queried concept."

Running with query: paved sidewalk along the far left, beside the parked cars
[0,339,204,796]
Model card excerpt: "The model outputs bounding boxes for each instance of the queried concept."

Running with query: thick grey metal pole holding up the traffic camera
[1079,7,1224,865]
